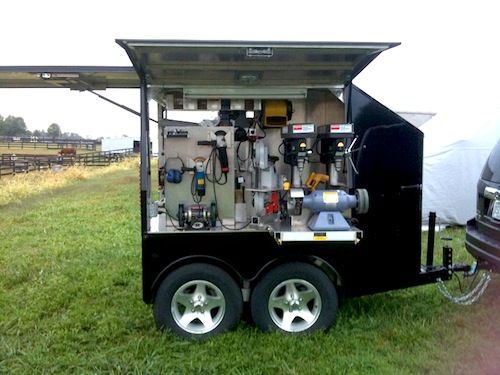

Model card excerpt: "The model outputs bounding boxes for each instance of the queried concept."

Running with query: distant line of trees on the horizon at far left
[0,115,83,139]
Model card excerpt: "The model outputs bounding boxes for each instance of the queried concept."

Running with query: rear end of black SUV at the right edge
[465,140,500,272]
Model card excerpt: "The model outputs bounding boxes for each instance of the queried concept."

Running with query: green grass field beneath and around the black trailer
[0,163,500,375]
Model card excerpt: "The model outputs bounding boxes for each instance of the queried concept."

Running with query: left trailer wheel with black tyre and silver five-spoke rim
[153,263,243,339]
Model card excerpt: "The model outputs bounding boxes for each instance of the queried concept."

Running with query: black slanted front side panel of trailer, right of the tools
[348,86,423,289]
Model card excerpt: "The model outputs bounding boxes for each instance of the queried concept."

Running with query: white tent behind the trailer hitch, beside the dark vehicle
[420,103,500,225]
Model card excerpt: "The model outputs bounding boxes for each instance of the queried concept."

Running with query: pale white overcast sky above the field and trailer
[0,0,500,137]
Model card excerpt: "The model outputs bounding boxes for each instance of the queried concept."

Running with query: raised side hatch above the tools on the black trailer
[117,39,399,96]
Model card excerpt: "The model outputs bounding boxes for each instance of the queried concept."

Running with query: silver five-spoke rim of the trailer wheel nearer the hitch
[268,279,321,332]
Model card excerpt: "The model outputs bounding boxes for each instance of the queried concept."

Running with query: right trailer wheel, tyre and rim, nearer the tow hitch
[250,263,338,333]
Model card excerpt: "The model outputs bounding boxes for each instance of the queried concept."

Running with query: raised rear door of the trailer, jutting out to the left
[0,66,139,91]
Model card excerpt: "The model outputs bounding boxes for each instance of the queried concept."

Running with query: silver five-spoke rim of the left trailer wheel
[171,280,226,334]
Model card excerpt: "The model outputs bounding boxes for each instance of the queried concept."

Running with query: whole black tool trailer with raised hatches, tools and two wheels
[0,40,476,338]
